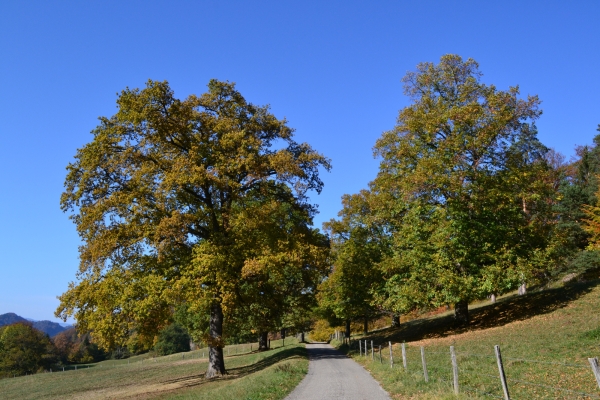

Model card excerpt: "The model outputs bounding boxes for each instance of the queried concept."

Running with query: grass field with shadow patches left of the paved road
[0,338,308,400]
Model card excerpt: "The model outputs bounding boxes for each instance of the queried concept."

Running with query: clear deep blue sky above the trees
[0,0,600,319]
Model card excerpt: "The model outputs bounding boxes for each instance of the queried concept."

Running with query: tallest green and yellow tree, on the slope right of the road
[374,55,552,323]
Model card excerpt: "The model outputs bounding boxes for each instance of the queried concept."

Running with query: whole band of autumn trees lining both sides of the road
[56,55,600,377]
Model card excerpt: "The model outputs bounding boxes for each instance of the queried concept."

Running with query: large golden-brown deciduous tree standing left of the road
[56,80,329,377]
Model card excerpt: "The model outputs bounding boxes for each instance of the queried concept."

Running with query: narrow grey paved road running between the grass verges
[286,344,390,400]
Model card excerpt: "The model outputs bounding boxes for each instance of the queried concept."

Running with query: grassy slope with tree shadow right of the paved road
[336,281,600,399]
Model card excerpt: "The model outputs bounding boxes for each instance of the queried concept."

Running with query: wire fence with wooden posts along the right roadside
[341,338,600,400]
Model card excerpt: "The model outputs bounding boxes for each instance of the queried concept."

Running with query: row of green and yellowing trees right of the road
[319,55,600,334]
